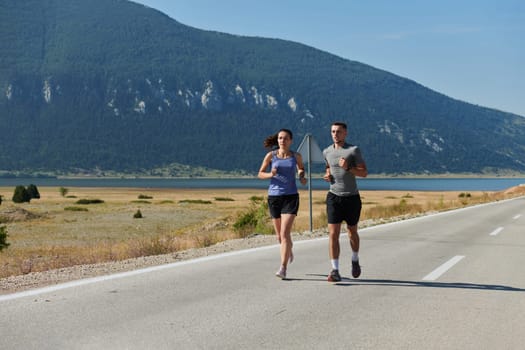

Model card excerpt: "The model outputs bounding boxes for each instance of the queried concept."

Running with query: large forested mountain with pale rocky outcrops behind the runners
[0,0,525,175]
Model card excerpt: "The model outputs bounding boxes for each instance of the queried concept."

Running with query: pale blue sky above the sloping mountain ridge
[135,0,525,116]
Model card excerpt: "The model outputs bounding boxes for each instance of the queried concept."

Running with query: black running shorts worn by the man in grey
[326,192,362,226]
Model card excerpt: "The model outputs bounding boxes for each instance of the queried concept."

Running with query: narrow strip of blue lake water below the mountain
[0,178,525,191]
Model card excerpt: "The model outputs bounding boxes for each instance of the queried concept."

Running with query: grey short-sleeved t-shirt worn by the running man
[323,143,364,196]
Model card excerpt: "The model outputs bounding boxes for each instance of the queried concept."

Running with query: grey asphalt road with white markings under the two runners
[0,198,525,349]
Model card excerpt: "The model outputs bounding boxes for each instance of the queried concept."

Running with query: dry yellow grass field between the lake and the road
[0,183,525,278]
